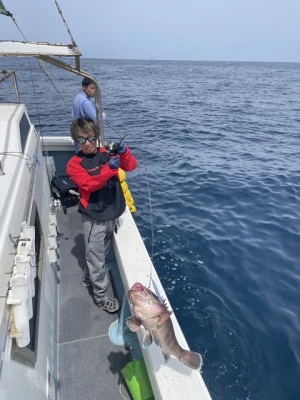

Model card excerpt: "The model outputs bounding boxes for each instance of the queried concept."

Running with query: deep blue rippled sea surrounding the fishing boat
[0,59,300,400]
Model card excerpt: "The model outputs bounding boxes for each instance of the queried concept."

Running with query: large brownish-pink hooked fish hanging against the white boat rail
[126,282,202,369]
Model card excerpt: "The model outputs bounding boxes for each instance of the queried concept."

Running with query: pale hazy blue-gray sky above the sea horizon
[0,0,300,62]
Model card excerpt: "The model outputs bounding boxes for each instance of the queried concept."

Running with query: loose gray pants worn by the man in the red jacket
[82,214,115,304]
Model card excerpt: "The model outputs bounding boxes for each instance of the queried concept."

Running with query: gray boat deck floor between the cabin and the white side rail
[57,207,131,400]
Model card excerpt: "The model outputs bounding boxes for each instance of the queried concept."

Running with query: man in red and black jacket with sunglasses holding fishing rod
[67,118,137,313]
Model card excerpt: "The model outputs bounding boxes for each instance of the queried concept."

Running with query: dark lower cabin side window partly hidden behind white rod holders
[11,201,44,366]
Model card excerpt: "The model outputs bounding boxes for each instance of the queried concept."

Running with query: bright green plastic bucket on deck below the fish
[122,358,155,400]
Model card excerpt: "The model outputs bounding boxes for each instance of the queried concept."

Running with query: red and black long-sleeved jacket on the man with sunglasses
[67,147,137,221]
